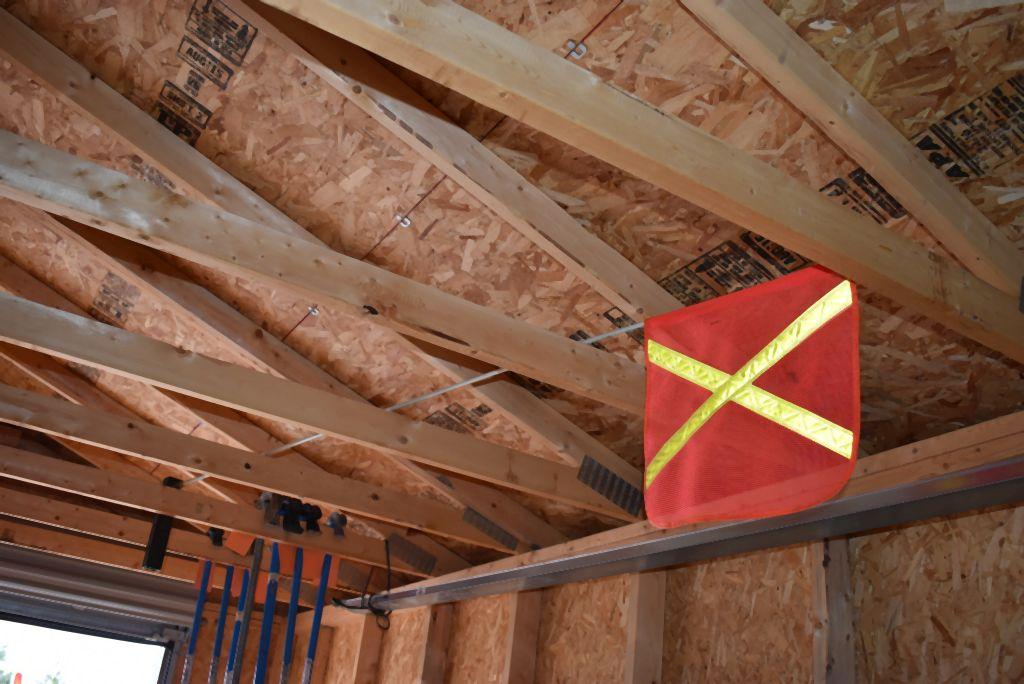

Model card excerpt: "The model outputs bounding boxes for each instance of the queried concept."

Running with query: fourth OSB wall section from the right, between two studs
[444,594,515,684]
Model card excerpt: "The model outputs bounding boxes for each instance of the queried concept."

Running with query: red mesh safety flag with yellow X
[644,267,860,527]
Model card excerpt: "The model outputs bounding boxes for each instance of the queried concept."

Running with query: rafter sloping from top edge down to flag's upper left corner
[233,0,680,320]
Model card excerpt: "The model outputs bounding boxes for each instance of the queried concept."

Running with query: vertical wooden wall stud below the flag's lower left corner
[626,571,666,684]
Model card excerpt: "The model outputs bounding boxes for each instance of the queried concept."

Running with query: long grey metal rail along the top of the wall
[343,450,1024,609]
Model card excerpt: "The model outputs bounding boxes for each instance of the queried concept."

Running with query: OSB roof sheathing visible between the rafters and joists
[0,0,1024,559]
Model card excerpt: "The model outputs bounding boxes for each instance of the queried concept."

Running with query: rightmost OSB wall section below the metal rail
[850,507,1024,682]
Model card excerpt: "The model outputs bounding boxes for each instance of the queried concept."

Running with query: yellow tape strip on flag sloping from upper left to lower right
[647,340,853,459]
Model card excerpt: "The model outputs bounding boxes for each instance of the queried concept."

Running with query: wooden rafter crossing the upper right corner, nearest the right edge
[682,0,1024,294]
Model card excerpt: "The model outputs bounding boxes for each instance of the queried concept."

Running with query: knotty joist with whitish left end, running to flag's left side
[0,131,643,413]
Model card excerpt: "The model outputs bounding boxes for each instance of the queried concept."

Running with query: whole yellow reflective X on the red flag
[644,281,853,487]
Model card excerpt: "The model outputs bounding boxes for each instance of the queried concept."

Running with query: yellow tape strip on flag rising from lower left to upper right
[644,281,853,487]
